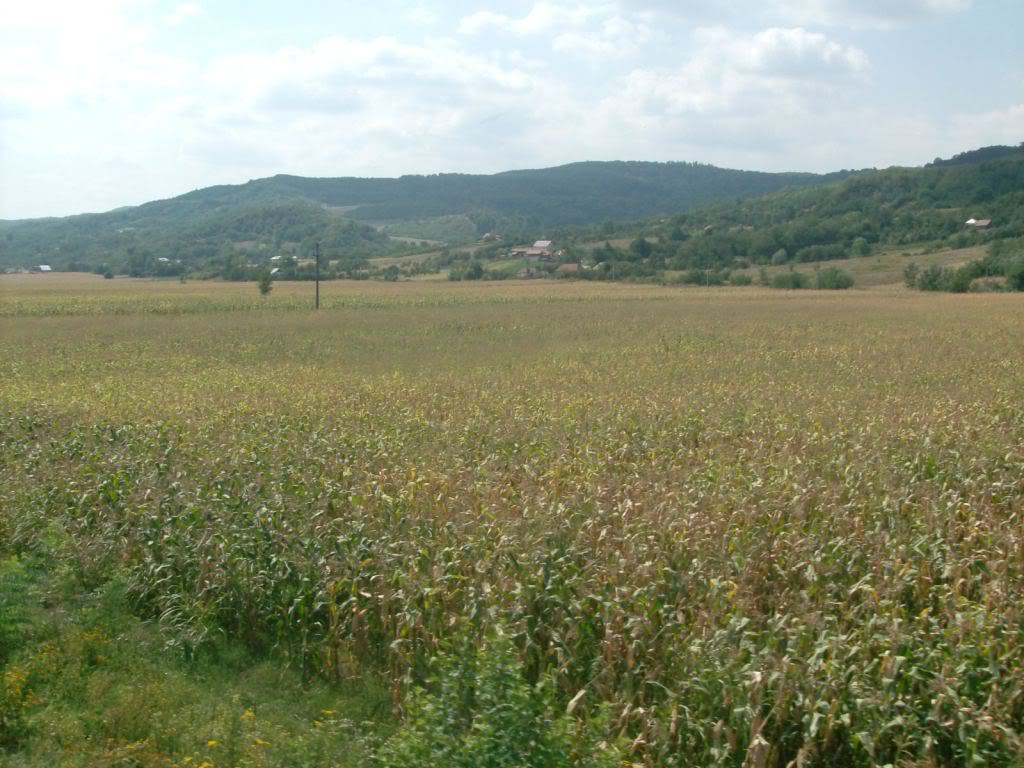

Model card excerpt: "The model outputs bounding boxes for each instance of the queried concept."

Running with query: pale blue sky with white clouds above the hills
[0,0,1024,219]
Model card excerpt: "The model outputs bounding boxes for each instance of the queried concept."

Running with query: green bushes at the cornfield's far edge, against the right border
[903,238,1024,293]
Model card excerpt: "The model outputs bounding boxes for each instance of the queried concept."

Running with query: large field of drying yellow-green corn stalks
[0,275,1024,767]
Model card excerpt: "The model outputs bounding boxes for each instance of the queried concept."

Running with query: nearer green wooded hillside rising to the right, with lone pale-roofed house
[561,147,1024,282]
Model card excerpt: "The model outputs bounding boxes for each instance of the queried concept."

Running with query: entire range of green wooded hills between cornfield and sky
[0,146,1024,282]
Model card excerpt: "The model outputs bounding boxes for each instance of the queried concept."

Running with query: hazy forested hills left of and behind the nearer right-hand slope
[0,162,846,271]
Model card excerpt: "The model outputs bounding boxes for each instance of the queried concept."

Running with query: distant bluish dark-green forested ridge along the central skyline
[167,162,846,227]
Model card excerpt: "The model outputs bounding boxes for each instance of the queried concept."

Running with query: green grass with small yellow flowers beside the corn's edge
[0,556,389,768]
